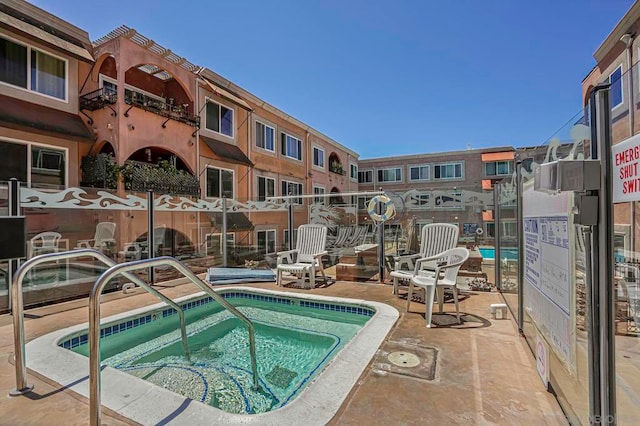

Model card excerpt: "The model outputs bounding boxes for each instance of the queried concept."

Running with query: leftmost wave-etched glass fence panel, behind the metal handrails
[13,186,146,312]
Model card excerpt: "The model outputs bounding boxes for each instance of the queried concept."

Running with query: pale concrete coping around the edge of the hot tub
[26,287,399,425]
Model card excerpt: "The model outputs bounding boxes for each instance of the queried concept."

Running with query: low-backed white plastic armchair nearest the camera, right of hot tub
[407,247,469,327]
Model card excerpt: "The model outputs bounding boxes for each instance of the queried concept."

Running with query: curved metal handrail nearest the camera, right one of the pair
[89,256,259,426]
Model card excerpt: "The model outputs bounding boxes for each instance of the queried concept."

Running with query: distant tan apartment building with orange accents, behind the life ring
[358,147,515,239]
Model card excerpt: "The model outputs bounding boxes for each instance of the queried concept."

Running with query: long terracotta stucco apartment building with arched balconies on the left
[0,0,358,251]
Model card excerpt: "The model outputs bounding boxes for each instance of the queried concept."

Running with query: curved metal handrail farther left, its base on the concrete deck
[9,249,190,396]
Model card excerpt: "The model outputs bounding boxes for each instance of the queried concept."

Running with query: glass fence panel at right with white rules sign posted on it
[512,112,590,424]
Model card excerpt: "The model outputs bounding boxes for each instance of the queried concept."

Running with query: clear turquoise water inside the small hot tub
[72,298,369,414]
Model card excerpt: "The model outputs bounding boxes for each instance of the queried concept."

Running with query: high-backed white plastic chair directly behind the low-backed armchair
[390,223,460,294]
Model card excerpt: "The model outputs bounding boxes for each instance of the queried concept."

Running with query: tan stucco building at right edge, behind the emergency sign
[582,1,640,260]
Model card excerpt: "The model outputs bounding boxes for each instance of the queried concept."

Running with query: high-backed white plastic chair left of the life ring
[276,224,327,288]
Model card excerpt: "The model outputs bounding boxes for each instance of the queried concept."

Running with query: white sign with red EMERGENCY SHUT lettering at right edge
[611,135,640,203]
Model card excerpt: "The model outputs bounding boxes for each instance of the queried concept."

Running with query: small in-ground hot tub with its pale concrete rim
[27,288,398,424]
